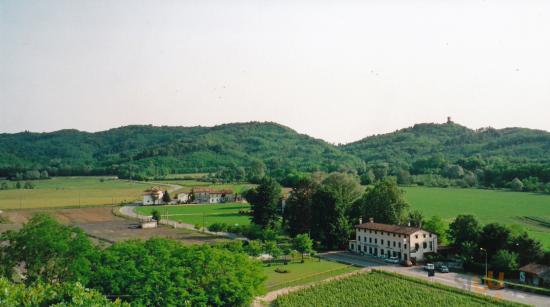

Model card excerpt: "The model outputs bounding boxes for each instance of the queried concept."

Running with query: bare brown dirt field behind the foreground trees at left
[0,207,224,244]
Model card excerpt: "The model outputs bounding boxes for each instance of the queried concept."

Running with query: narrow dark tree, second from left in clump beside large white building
[284,178,318,236]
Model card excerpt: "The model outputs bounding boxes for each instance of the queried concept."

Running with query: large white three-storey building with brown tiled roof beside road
[349,219,437,262]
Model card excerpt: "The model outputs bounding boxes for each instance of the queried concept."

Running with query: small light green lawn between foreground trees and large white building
[264,259,359,291]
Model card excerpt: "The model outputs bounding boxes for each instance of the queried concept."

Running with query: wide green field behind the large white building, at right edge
[403,187,550,249]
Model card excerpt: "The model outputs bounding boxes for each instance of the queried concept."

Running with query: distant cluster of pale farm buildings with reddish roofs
[143,188,242,205]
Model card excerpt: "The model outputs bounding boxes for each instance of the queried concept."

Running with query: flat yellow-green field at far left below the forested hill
[0,177,168,210]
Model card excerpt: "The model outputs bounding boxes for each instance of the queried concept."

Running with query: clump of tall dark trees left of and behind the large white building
[245,173,418,249]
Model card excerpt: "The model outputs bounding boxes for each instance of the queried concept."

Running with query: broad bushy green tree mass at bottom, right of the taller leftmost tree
[90,238,265,306]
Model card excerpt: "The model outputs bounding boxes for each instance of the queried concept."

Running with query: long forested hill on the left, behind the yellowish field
[0,122,364,178]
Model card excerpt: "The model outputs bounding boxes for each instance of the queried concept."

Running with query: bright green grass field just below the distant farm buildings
[136,203,250,226]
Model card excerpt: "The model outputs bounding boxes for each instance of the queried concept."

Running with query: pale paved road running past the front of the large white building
[319,252,550,307]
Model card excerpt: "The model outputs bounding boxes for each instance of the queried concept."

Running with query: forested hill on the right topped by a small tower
[340,122,550,190]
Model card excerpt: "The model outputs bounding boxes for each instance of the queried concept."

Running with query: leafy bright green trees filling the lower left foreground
[0,214,264,306]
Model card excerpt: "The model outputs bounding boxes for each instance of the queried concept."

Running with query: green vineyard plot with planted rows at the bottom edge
[274,271,521,307]
